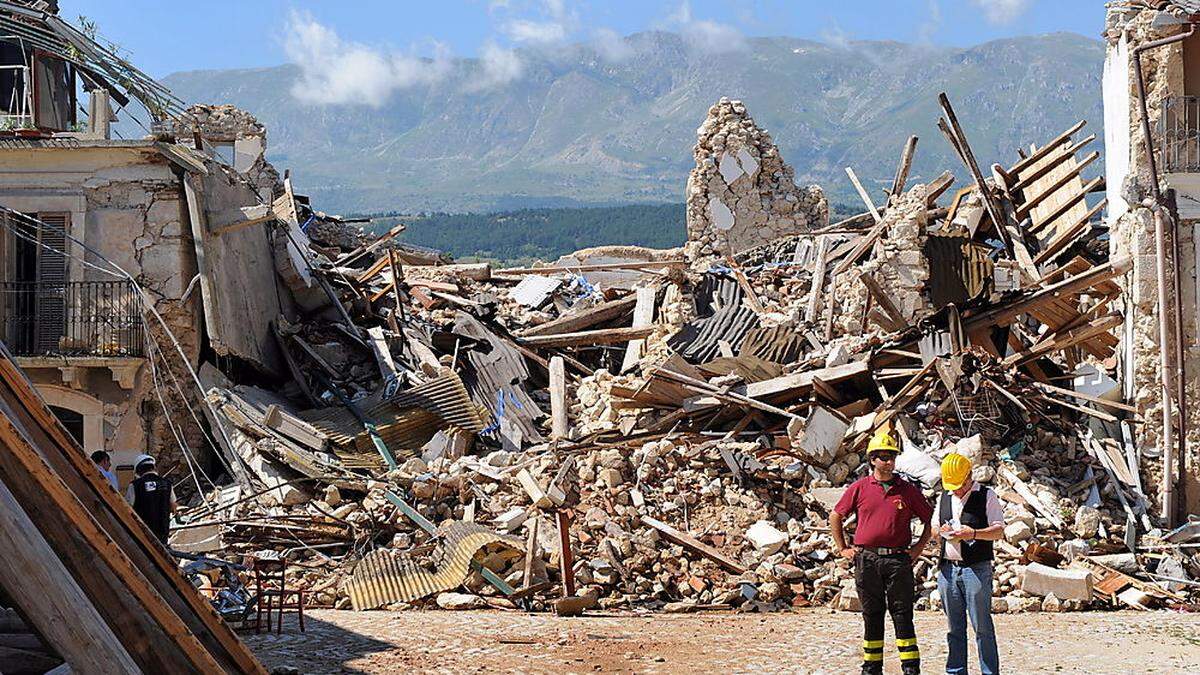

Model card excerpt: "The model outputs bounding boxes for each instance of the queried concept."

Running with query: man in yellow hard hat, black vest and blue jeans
[934,453,1004,675]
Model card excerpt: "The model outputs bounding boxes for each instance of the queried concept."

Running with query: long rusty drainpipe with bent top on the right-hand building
[1133,23,1196,526]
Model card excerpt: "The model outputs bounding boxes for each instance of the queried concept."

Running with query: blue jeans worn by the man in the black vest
[937,561,1000,675]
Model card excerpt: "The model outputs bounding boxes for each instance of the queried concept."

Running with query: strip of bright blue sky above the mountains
[59,0,1104,77]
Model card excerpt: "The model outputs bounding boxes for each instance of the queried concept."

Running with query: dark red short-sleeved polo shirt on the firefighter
[834,473,934,549]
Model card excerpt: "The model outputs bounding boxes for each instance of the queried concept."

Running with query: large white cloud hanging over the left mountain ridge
[283,11,450,107]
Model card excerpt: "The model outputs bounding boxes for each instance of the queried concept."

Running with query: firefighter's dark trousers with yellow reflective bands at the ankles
[854,550,920,675]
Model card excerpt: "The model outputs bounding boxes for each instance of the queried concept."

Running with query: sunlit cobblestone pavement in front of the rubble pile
[246,610,1200,674]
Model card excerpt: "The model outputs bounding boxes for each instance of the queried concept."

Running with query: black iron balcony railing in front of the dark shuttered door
[0,281,145,357]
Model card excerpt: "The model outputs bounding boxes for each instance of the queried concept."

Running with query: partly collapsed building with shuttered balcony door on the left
[0,2,287,483]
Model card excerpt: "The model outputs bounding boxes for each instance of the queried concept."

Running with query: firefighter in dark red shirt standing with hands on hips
[829,429,934,675]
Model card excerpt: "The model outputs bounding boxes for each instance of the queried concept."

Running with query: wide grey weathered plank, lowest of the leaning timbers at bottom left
[0,473,140,674]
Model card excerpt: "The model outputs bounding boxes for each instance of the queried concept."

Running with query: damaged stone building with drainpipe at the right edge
[1103,0,1200,519]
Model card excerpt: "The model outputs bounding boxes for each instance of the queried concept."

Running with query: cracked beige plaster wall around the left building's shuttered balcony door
[0,144,204,480]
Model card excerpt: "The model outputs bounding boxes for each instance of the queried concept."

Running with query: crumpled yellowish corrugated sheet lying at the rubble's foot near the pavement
[346,522,523,610]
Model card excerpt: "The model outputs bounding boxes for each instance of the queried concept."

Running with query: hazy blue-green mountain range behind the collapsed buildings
[163,32,1104,213]
